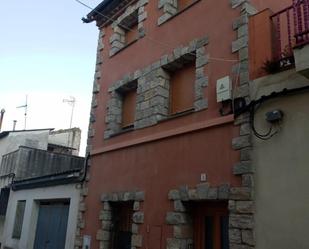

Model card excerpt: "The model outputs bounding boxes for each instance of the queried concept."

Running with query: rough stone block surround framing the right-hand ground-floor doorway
[166,183,254,249]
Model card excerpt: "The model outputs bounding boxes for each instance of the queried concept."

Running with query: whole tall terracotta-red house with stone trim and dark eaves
[76,0,291,249]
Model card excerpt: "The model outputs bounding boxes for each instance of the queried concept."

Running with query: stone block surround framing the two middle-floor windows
[104,37,208,139]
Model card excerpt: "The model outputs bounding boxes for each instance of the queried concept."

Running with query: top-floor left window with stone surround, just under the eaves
[109,0,149,56]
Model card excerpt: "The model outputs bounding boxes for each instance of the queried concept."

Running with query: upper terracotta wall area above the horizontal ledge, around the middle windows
[92,1,238,152]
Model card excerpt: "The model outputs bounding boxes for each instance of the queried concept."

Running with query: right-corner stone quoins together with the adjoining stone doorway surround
[166,0,256,249]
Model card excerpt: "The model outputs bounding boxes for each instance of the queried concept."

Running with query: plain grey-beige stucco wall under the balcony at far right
[251,70,309,249]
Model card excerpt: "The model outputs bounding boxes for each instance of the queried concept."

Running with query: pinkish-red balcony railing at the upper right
[271,0,309,61]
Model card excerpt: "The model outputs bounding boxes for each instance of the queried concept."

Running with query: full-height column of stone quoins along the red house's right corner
[229,0,257,249]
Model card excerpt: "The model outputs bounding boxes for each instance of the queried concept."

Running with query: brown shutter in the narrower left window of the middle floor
[122,89,136,128]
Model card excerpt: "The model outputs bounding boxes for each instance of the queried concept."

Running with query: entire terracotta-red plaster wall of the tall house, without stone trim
[74,0,296,249]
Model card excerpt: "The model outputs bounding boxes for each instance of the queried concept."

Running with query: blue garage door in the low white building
[33,203,69,249]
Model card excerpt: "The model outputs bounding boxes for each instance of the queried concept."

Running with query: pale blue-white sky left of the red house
[0,0,101,155]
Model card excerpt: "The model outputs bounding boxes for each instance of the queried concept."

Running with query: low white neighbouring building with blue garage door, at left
[0,128,85,249]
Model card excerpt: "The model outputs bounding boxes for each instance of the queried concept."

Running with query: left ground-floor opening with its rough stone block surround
[97,191,145,249]
